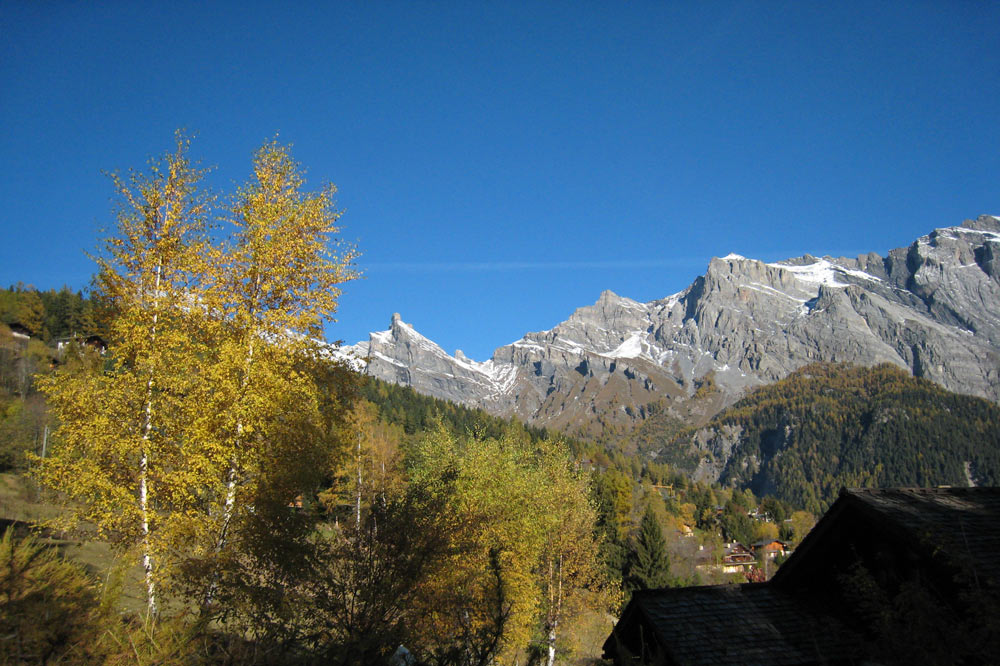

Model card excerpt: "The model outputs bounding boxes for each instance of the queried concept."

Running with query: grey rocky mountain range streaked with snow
[342,216,1000,427]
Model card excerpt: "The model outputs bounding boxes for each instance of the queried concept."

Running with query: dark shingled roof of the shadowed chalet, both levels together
[604,488,1000,666]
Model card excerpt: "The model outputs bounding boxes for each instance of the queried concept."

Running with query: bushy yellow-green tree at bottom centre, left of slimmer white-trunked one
[409,429,544,665]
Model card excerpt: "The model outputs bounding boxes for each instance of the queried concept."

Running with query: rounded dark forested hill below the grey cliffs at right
[661,364,1000,512]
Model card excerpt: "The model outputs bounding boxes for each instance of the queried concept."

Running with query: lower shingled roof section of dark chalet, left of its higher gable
[604,583,857,666]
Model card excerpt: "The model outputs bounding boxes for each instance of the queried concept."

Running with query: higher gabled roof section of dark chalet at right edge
[774,488,1000,583]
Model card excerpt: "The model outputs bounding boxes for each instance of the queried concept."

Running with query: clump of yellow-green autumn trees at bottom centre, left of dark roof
[410,430,612,664]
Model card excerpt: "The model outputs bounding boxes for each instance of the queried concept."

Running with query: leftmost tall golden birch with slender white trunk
[36,134,212,613]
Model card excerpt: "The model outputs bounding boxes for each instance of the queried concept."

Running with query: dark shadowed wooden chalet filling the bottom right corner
[604,488,1000,666]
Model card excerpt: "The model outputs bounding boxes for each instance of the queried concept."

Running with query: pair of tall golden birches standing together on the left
[38,137,354,624]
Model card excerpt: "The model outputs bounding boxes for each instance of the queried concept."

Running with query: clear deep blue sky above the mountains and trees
[0,0,1000,360]
